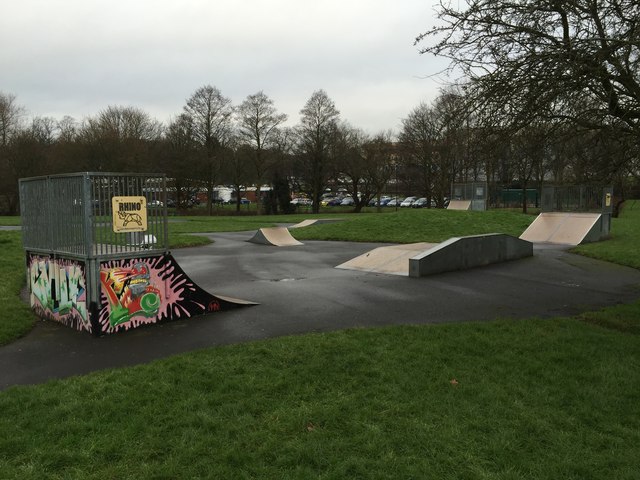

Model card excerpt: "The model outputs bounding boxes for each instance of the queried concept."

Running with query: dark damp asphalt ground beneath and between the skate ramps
[0,232,640,389]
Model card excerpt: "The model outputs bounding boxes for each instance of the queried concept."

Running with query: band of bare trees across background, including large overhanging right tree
[0,0,640,213]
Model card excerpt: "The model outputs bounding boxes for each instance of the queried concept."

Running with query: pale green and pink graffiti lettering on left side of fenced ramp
[27,254,92,332]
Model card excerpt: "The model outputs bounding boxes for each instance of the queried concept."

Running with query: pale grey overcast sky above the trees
[0,0,445,133]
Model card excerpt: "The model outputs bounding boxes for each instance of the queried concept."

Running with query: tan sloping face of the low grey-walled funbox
[336,243,437,277]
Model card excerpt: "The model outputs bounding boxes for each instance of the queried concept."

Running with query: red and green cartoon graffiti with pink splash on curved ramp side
[98,253,246,333]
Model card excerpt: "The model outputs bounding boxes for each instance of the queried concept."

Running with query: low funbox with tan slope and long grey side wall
[336,233,533,277]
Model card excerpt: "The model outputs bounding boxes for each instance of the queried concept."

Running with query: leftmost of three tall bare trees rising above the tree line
[184,85,233,214]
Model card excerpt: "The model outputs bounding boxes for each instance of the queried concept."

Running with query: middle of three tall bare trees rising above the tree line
[237,91,287,214]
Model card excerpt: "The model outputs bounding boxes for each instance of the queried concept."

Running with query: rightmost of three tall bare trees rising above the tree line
[298,90,340,213]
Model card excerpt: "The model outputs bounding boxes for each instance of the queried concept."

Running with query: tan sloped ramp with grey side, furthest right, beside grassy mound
[520,212,603,245]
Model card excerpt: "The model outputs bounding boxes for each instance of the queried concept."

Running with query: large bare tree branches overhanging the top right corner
[416,0,640,172]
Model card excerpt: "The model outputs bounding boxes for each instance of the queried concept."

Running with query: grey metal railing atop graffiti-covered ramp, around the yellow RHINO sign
[19,172,168,261]
